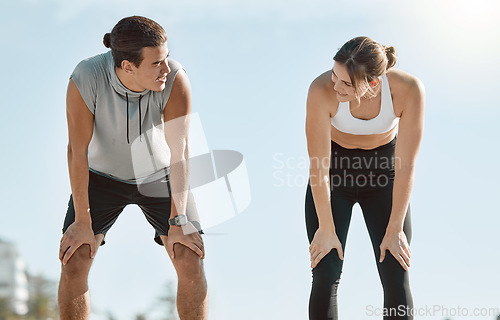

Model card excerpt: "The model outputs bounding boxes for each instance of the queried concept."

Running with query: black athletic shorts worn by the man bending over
[63,171,203,245]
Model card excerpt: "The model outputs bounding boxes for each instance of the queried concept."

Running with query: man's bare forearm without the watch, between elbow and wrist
[68,148,91,223]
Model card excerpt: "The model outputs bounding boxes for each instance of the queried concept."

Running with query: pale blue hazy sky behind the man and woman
[0,0,500,320]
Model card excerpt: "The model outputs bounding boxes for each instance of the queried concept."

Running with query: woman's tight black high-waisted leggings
[305,139,413,320]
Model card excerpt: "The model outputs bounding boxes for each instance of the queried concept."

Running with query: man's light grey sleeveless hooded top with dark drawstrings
[71,51,183,184]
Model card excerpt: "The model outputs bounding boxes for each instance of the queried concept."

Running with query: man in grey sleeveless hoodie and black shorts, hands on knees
[59,16,207,320]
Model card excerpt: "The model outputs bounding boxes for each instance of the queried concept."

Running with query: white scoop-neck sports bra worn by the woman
[332,74,399,135]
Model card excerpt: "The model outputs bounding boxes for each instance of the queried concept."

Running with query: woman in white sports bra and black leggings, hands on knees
[305,37,424,320]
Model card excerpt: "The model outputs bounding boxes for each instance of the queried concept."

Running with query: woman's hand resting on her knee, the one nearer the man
[309,228,344,268]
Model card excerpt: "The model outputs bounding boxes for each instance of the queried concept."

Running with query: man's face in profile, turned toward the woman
[133,42,170,92]
